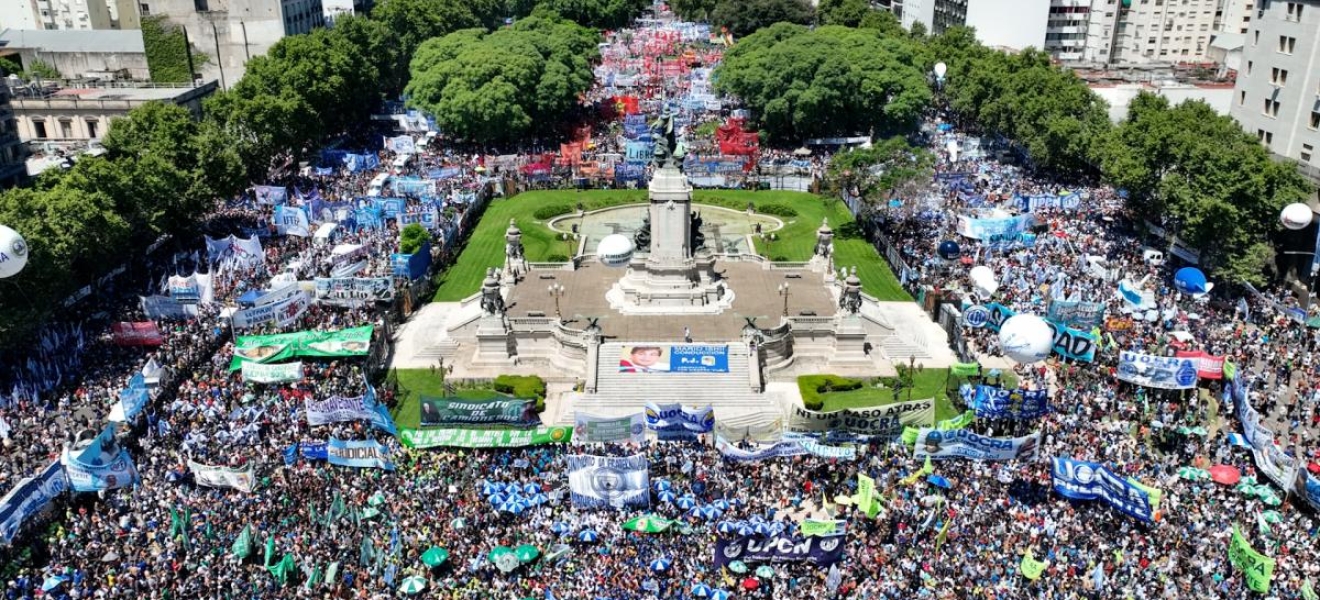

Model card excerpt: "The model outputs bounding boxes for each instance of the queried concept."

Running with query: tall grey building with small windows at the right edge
[1230,0,1320,182]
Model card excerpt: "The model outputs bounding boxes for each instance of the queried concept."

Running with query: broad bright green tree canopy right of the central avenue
[715,22,931,140]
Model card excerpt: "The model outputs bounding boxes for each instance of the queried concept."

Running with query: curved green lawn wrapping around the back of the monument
[434,190,912,302]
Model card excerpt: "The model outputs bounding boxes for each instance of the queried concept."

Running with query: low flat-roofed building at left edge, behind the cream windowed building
[0,29,150,80]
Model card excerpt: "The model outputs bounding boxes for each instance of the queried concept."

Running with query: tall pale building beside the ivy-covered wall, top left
[139,0,325,88]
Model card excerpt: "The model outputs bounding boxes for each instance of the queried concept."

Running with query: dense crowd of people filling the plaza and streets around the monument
[0,7,1320,600]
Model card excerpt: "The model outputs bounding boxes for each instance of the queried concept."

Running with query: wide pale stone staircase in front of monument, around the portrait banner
[567,343,784,426]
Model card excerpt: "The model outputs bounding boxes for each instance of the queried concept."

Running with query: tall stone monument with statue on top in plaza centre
[606,113,734,315]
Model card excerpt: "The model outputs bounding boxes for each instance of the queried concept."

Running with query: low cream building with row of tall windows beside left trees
[0,82,219,144]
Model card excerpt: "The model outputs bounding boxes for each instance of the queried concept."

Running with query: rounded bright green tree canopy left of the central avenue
[407,15,598,142]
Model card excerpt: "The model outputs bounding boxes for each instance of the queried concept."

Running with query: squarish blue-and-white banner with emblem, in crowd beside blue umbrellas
[568,454,651,509]
